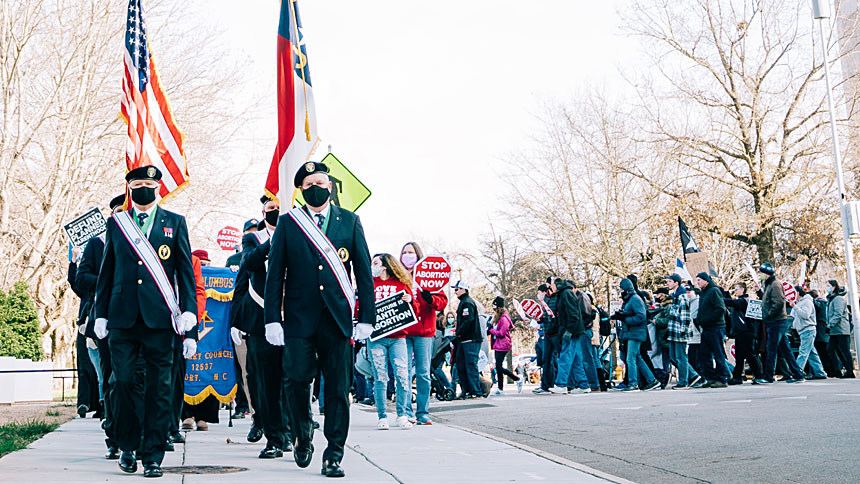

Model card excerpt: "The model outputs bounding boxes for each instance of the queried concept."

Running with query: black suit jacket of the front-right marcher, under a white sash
[265,205,376,338]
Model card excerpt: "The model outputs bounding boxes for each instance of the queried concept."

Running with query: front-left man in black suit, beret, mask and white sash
[95,166,197,477]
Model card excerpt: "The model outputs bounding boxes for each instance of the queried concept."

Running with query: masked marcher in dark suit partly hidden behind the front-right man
[231,196,293,459]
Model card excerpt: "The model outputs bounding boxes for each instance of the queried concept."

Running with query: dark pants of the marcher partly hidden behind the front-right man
[248,334,290,449]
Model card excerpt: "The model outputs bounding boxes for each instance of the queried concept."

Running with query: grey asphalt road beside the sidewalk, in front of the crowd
[431,379,860,484]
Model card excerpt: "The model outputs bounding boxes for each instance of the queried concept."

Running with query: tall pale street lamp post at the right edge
[812,0,860,367]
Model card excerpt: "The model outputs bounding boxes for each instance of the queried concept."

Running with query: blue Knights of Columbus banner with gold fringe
[185,266,236,405]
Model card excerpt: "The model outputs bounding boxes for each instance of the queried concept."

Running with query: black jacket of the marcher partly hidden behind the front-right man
[230,234,271,336]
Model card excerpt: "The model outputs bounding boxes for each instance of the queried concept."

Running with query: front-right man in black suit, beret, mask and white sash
[265,162,376,477]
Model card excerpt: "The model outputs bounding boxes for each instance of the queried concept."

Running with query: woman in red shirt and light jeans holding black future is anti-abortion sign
[367,254,414,430]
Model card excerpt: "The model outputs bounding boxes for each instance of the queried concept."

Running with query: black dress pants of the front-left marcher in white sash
[108,315,176,465]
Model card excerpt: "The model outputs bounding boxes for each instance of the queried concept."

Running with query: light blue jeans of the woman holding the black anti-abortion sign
[368,338,409,418]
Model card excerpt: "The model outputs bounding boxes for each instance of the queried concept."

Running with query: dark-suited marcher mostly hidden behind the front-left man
[75,194,128,460]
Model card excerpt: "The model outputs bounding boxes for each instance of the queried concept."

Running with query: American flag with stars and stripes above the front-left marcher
[122,0,188,197]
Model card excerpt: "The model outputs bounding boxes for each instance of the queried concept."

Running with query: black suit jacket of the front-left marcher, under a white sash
[95,207,197,329]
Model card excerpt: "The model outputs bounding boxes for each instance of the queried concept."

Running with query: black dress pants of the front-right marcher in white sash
[283,307,355,462]
